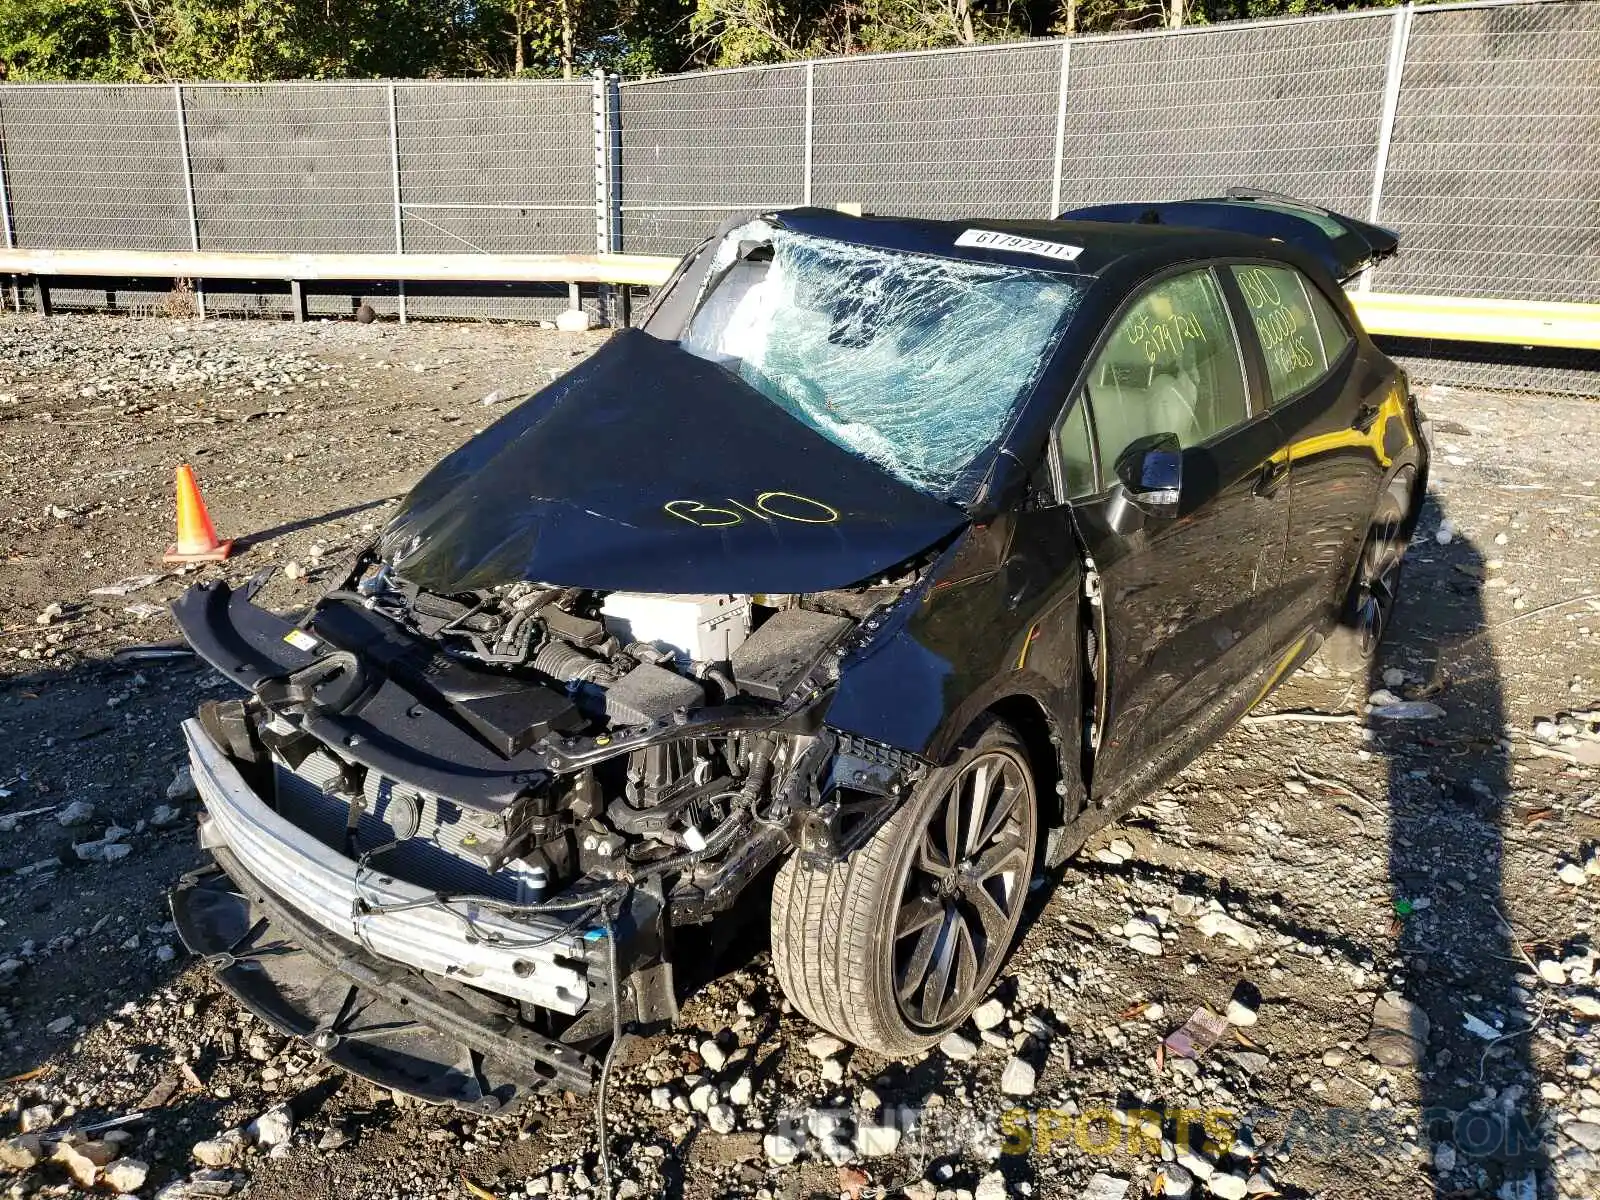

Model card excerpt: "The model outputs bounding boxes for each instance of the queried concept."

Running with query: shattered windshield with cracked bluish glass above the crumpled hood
[682,224,1083,501]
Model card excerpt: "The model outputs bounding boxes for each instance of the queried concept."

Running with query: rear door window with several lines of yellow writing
[1232,266,1352,408]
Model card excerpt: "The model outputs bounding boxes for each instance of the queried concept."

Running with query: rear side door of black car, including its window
[1227,262,1400,632]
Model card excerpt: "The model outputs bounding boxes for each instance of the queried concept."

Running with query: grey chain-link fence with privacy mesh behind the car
[0,0,1600,390]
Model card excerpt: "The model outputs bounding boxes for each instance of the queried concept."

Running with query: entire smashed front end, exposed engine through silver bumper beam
[164,552,930,1102]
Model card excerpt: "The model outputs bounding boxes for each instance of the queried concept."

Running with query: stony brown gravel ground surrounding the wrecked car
[0,317,1600,1200]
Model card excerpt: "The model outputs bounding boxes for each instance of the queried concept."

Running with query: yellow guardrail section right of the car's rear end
[1350,291,1600,350]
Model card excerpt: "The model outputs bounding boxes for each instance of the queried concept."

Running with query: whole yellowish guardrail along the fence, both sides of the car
[0,250,1600,350]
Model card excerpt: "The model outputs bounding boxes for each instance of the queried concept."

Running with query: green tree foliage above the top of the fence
[0,0,1384,82]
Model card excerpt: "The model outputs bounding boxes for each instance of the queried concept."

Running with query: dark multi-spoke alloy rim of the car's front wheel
[893,749,1035,1029]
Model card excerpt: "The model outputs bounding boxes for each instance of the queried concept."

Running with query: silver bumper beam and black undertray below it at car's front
[171,720,613,1112]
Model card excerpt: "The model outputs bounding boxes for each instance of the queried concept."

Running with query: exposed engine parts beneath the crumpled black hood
[286,562,915,915]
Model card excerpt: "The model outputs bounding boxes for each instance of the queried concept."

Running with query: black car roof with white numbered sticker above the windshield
[768,208,1304,277]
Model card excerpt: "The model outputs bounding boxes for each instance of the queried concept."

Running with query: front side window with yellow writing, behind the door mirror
[1086,270,1250,475]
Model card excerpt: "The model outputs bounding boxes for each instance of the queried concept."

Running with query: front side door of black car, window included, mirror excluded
[1056,267,1290,803]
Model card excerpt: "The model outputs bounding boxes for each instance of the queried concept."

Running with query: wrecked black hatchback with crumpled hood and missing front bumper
[173,194,1427,1112]
